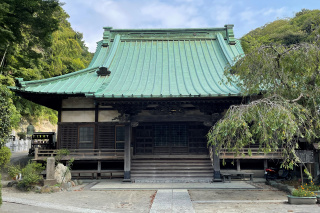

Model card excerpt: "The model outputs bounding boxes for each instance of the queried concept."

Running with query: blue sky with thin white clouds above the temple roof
[61,0,320,52]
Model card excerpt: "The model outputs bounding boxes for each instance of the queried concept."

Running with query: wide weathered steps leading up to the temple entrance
[131,155,213,183]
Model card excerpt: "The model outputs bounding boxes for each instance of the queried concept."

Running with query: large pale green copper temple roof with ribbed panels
[11,25,243,98]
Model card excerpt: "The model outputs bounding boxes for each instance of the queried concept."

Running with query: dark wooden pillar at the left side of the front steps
[123,123,131,182]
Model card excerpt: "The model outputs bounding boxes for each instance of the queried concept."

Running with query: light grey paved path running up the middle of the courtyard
[150,189,195,213]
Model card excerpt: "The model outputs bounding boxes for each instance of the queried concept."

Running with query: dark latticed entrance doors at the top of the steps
[133,122,209,155]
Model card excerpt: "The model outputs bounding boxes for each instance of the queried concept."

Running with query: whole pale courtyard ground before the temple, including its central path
[0,179,320,213]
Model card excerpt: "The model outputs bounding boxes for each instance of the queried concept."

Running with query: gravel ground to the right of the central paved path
[189,183,320,213]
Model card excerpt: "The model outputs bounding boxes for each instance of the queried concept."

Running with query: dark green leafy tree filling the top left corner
[0,0,59,69]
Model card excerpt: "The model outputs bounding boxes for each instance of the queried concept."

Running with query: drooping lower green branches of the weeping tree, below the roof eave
[207,95,320,168]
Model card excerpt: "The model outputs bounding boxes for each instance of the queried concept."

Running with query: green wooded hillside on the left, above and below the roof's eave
[0,0,92,138]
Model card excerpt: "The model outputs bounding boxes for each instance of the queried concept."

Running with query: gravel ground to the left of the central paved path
[0,187,156,213]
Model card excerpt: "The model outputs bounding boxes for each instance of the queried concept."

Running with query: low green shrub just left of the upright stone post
[18,162,44,190]
